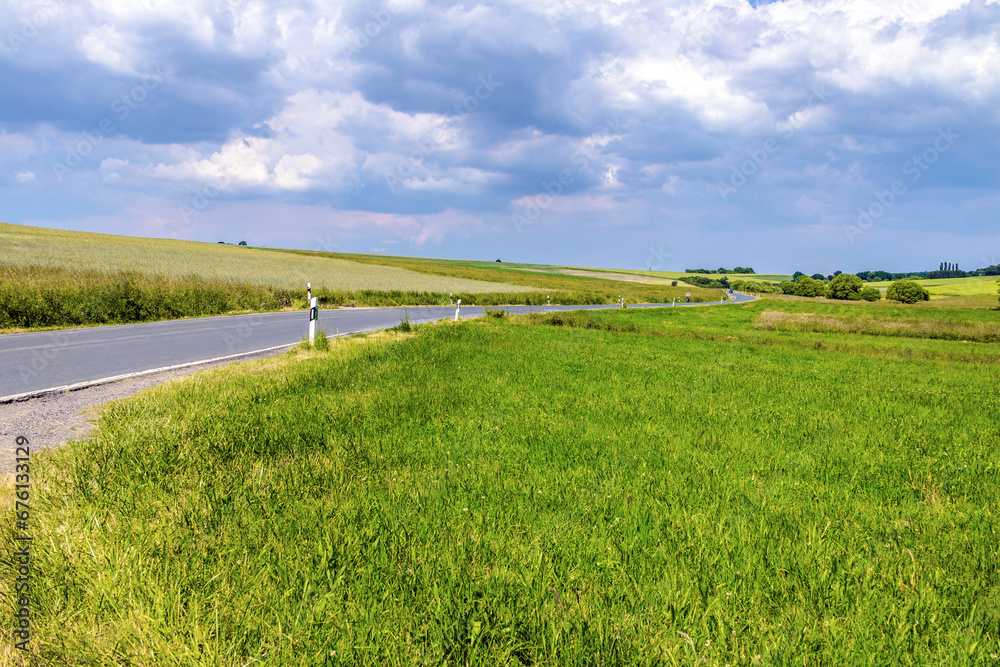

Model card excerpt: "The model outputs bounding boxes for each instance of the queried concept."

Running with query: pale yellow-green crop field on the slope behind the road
[0,223,532,294]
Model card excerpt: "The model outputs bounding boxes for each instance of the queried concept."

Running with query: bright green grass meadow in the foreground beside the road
[0,299,1000,666]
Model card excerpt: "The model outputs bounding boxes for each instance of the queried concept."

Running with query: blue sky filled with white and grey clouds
[0,0,1000,274]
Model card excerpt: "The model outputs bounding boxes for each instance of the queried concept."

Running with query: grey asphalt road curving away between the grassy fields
[0,294,752,403]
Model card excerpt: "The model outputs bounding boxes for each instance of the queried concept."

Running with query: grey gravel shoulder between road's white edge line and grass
[0,350,284,480]
